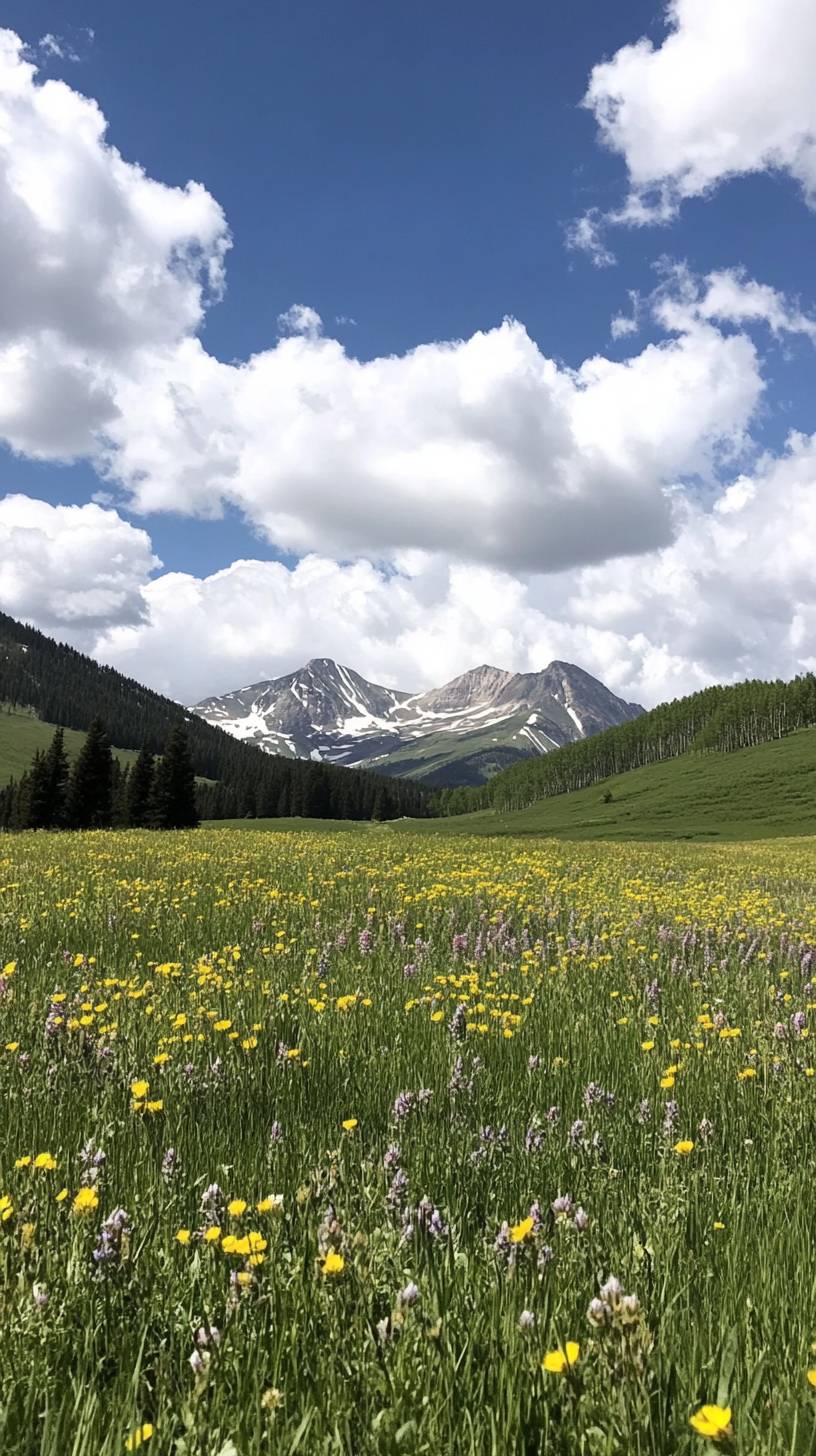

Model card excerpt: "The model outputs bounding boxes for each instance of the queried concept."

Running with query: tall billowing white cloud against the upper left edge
[0,29,229,459]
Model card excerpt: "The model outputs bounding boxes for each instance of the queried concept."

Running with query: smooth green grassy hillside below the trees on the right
[391,728,816,840]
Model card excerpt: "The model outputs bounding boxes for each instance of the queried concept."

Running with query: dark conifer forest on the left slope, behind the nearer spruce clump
[0,613,436,820]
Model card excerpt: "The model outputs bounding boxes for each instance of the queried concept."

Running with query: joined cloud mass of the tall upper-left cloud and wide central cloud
[0,31,762,571]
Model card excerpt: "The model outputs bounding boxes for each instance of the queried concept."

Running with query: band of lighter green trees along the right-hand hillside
[439,673,816,814]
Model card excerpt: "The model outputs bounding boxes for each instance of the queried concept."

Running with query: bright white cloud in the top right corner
[584,0,816,223]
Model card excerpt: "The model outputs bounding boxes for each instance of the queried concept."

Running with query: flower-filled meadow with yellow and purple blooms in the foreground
[0,828,816,1456]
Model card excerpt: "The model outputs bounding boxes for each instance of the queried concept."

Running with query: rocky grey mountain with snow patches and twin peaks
[192,657,643,785]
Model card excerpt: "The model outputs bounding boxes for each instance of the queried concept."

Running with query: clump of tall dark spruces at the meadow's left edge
[0,718,198,830]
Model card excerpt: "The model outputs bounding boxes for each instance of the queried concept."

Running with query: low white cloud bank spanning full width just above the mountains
[0,422,816,705]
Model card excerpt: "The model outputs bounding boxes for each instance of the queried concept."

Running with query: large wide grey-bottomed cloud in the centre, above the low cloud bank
[100,320,762,571]
